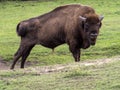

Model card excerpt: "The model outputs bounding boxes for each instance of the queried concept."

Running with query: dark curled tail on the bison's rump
[16,23,27,37]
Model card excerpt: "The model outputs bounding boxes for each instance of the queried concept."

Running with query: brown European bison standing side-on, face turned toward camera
[11,4,103,69]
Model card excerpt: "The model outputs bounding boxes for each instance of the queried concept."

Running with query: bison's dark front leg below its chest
[69,45,81,62]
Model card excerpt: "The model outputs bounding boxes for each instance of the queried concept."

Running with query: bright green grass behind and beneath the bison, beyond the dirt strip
[0,0,120,65]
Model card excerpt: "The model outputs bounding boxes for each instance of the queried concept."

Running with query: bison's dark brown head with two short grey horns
[80,15,103,45]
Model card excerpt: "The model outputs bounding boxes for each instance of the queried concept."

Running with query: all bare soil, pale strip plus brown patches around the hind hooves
[0,56,120,74]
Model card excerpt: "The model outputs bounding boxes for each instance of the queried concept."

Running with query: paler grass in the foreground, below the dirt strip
[0,59,120,90]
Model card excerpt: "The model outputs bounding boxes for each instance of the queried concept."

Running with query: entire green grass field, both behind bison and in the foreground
[0,0,120,90]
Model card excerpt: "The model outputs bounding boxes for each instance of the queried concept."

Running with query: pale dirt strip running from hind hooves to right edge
[28,56,120,74]
